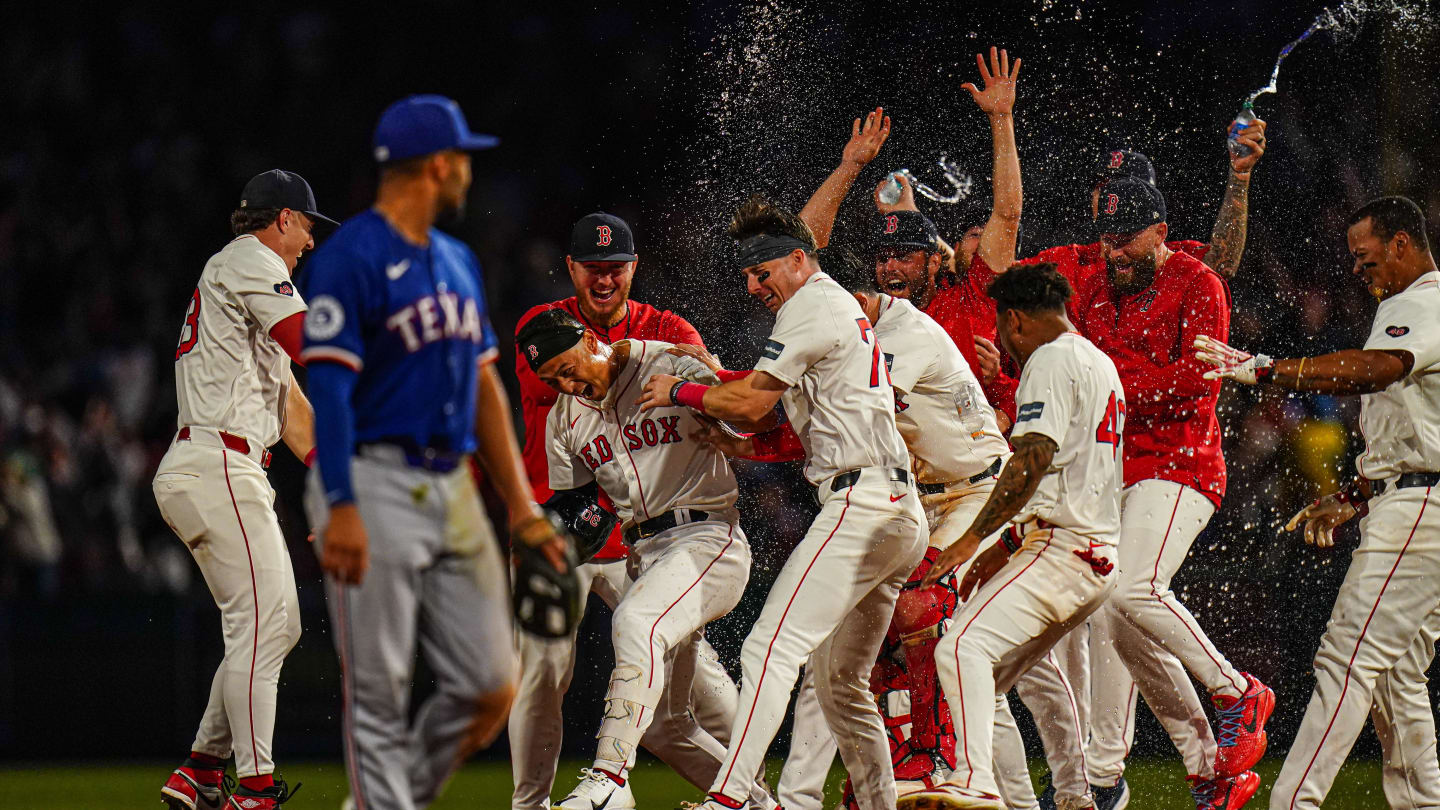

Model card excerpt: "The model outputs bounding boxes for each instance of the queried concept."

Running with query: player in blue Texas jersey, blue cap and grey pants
[302,95,577,810]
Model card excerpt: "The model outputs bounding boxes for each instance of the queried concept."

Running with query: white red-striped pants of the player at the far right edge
[1270,487,1440,810]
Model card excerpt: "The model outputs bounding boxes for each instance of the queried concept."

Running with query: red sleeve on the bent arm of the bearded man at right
[1106,271,1230,419]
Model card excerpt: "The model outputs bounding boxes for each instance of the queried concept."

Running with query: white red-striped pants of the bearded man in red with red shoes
[1089,479,1247,785]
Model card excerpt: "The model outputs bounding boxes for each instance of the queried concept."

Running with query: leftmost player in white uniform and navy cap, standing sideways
[151,170,334,810]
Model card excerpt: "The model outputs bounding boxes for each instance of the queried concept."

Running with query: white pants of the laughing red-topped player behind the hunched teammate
[510,559,739,810]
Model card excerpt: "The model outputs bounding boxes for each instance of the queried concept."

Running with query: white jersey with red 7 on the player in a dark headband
[755,272,910,484]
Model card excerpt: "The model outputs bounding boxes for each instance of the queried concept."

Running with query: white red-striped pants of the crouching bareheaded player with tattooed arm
[935,528,1115,796]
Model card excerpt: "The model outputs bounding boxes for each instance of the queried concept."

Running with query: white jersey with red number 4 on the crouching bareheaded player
[1009,331,1125,545]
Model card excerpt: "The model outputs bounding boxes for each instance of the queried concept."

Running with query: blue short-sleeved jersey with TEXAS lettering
[301,210,498,453]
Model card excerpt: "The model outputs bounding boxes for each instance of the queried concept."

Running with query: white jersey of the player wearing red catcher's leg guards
[876,295,1009,484]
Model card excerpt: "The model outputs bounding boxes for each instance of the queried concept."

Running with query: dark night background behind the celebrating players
[0,0,1440,761]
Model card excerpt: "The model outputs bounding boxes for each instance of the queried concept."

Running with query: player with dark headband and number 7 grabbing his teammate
[642,199,924,810]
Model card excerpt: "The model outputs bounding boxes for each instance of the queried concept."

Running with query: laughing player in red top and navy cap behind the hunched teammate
[510,212,754,810]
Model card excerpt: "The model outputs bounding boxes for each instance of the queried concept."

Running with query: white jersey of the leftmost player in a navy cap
[176,233,305,447]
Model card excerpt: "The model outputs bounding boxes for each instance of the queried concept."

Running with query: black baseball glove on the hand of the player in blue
[510,512,580,638]
